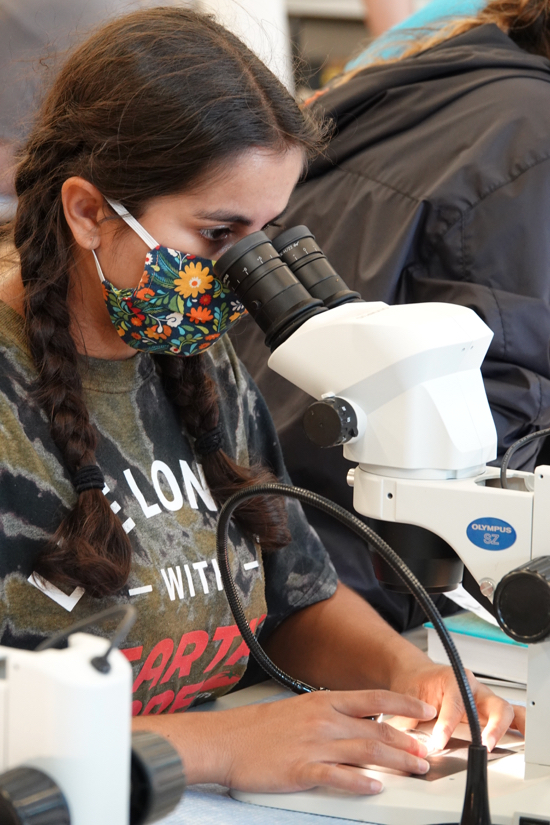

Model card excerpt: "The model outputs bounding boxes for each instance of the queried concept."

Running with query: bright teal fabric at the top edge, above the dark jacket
[346,0,485,71]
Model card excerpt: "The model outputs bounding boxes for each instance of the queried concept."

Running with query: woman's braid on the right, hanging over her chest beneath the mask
[156,355,291,550]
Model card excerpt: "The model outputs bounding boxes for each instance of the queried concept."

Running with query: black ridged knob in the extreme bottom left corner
[0,767,71,825]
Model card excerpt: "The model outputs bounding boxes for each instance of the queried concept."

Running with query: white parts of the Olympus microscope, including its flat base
[239,303,550,825]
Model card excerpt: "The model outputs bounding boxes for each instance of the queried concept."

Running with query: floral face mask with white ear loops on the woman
[93,198,246,355]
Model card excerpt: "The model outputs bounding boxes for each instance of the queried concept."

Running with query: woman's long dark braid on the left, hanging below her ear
[14,145,131,596]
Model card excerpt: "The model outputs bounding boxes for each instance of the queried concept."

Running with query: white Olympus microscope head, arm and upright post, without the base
[269,303,550,771]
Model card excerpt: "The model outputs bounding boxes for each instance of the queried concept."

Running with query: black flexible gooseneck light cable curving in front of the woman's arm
[217,484,491,825]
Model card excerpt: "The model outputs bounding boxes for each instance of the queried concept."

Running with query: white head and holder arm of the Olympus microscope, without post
[269,303,508,582]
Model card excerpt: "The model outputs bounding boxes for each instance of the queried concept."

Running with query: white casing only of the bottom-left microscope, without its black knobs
[0,633,132,825]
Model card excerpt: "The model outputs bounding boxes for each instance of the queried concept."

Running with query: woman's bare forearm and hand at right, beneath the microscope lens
[266,584,525,750]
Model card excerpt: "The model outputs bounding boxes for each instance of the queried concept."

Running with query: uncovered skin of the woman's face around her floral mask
[92,148,304,287]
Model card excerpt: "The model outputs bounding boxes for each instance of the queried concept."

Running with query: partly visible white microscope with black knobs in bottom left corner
[0,628,185,825]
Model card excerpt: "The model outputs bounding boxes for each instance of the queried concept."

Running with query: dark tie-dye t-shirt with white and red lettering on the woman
[0,304,336,715]
